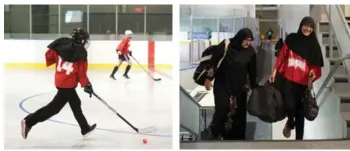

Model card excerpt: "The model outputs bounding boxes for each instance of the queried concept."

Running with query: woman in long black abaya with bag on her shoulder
[205,28,256,140]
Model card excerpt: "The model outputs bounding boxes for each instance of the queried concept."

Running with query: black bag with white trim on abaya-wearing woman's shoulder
[193,40,230,86]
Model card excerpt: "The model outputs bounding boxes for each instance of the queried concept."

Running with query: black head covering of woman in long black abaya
[230,28,254,50]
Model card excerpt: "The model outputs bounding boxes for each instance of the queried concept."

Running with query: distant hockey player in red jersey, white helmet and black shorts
[110,30,132,80]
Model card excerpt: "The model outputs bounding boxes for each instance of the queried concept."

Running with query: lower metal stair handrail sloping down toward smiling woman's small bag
[316,54,350,106]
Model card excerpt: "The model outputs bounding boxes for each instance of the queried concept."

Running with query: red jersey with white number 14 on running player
[45,49,89,88]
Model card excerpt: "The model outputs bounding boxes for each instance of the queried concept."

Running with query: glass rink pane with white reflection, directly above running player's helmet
[60,5,87,35]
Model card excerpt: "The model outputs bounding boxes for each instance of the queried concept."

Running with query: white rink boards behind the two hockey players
[3,40,172,65]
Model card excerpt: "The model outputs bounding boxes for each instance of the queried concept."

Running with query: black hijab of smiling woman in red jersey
[285,16,324,67]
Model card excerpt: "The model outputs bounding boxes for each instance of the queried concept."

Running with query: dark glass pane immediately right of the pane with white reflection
[89,5,116,35]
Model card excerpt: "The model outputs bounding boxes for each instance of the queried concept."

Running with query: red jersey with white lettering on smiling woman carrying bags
[275,44,321,85]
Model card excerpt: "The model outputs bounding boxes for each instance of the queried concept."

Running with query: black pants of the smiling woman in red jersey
[283,80,306,140]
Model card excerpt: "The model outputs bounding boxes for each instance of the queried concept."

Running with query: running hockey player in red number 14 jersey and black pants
[21,28,96,139]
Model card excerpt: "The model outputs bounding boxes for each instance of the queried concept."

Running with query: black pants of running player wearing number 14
[25,88,90,133]
